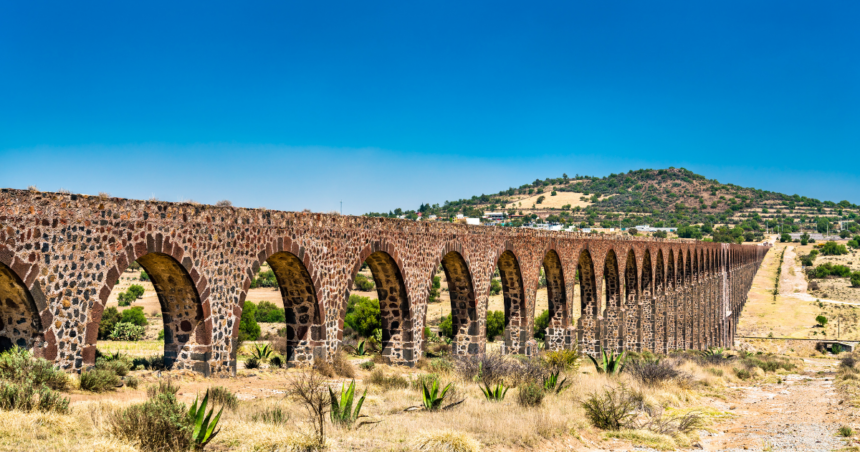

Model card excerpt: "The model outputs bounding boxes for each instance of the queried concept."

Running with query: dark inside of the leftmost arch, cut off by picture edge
[0,263,43,352]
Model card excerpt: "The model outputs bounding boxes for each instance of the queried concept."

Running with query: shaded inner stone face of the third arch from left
[266,251,325,362]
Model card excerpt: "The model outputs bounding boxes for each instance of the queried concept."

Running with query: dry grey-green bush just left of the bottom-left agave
[108,392,193,452]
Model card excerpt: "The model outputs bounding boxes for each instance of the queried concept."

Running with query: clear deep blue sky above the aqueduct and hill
[0,0,860,214]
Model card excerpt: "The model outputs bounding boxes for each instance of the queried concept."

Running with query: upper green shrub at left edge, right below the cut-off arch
[0,346,69,391]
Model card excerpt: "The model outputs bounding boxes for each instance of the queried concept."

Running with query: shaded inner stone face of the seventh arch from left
[535,250,569,350]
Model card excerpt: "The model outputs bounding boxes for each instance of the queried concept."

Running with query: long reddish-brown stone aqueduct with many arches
[0,189,768,375]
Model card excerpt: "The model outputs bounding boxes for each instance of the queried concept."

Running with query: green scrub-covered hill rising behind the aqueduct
[367,168,860,242]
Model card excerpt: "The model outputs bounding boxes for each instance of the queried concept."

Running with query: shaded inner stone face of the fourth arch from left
[352,241,416,365]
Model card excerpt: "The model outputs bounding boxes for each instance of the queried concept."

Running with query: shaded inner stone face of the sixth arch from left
[496,250,533,353]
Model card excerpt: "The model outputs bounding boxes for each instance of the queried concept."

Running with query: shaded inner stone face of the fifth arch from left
[440,249,482,355]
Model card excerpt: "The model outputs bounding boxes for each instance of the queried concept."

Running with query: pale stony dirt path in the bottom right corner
[701,359,857,451]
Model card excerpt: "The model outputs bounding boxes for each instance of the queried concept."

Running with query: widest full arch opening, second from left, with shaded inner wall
[96,252,211,375]
